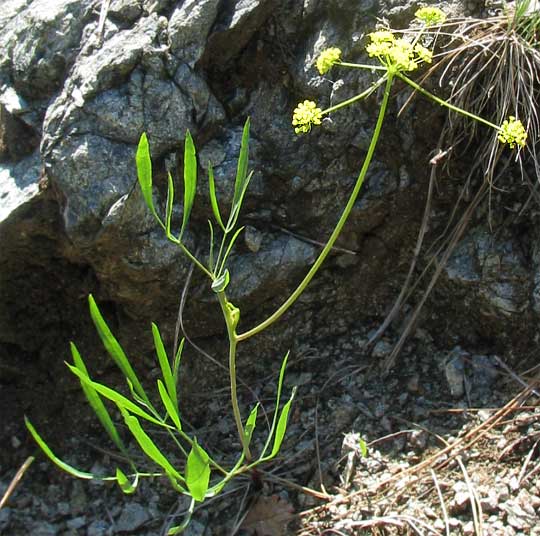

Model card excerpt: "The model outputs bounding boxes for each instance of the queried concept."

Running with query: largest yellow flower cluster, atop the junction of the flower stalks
[366,30,433,71]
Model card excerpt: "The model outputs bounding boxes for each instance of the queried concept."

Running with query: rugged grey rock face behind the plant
[0,0,540,394]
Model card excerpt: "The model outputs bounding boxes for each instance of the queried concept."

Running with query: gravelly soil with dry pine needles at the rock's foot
[0,320,540,536]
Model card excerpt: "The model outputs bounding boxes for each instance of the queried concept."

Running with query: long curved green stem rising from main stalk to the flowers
[236,72,394,341]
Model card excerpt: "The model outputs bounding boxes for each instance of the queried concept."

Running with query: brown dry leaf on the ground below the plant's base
[240,495,294,536]
